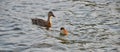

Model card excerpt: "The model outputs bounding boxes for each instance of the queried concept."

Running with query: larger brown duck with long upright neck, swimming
[31,11,55,30]
